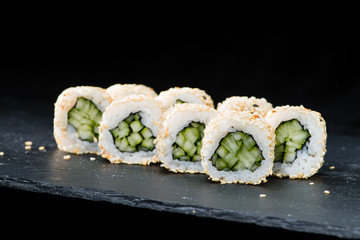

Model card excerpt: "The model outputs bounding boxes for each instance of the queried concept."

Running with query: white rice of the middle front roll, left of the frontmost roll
[156,103,217,173]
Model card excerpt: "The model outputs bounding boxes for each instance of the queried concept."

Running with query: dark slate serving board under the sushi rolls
[0,99,360,238]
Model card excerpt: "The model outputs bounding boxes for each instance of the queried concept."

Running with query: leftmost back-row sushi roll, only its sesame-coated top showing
[106,84,158,101]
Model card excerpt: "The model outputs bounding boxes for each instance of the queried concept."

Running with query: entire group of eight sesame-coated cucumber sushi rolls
[54,84,327,185]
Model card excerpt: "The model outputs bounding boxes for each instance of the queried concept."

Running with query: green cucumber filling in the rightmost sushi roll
[274,119,310,163]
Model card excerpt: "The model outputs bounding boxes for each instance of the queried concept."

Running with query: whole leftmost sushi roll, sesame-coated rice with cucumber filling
[54,86,111,154]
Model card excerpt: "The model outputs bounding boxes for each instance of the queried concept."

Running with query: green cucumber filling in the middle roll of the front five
[172,122,205,162]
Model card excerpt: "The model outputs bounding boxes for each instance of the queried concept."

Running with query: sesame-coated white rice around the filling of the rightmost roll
[266,106,327,178]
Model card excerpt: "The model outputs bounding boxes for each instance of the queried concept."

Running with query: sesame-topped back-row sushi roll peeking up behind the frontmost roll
[217,96,273,117]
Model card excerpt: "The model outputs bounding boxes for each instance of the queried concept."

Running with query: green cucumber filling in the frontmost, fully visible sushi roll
[211,131,264,171]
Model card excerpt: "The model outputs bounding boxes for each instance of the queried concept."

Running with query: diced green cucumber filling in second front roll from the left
[110,112,155,152]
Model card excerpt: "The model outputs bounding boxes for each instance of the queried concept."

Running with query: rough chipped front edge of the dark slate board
[0,175,360,238]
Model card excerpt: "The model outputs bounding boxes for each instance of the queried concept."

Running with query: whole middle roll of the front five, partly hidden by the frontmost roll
[156,103,216,173]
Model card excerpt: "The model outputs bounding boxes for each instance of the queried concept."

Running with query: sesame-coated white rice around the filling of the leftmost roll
[54,86,111,154]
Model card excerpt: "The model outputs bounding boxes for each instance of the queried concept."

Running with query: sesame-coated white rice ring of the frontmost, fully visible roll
[201,111,275,184]
